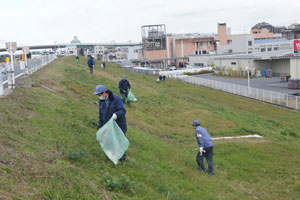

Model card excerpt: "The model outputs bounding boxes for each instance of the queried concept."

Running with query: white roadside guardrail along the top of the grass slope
[0,55,57,96]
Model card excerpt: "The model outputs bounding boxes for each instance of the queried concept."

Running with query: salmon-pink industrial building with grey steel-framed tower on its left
[139,24,216,69]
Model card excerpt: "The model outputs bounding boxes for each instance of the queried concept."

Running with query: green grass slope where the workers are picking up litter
[0,57,300,200]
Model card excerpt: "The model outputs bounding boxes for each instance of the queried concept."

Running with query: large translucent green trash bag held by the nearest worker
[96,118,129,165]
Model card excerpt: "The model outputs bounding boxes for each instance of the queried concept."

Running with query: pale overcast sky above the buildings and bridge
[0,0,300,47]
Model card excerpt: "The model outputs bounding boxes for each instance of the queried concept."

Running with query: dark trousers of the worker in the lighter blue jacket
[196,147,214,174]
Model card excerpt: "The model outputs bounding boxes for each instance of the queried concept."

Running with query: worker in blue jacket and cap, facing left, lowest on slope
[192,120,214,175]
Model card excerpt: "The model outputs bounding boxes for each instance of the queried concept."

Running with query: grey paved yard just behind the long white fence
[195,74,300,94]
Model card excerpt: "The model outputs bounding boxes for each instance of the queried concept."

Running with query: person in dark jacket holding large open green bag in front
[94,85,127,162]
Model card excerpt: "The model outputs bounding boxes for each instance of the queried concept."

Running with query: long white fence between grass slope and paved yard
[178,76,300,110]
